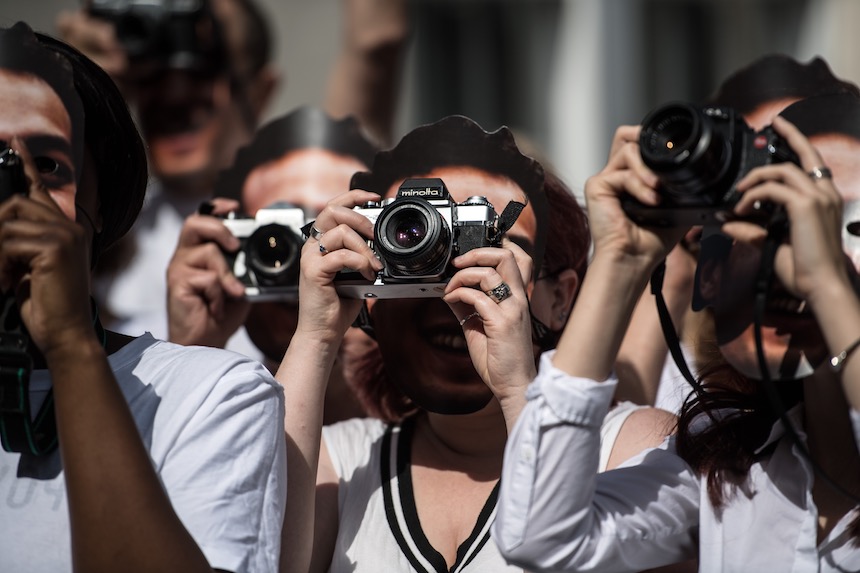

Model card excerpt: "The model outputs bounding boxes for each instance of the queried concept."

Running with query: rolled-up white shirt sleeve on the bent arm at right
[493,357,699,571]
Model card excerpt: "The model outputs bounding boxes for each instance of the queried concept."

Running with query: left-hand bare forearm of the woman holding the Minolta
[275,332,339,573]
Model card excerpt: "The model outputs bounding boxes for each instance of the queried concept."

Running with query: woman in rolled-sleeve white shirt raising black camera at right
[493,104,860,571]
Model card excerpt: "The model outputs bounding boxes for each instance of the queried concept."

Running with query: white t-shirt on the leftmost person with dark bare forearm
[0,334,286,573]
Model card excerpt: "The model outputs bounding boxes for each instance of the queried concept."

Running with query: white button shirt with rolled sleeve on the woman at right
[492,353,860,572]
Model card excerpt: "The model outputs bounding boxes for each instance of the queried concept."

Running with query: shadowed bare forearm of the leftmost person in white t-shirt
[46,337,211,572]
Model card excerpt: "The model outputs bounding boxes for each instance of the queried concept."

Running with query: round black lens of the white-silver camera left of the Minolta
[245,224,301,286]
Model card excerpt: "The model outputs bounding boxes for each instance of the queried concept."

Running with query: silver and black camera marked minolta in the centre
[335,179,525,298]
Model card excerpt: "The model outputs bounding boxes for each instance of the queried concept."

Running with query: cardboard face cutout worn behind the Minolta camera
[340,116,548,414]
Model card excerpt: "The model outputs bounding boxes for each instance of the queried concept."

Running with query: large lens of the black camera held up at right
[639,104,742,205]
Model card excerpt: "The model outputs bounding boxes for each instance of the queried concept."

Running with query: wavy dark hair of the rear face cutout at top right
[707,54,860,114]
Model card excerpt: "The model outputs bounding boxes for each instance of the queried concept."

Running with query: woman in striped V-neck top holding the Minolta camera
[276,117,671,572]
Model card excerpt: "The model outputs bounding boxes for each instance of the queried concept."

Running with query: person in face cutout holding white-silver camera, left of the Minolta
[167,106,376,423]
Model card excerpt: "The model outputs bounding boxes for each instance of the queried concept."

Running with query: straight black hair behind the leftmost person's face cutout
[36,30,148,256]
